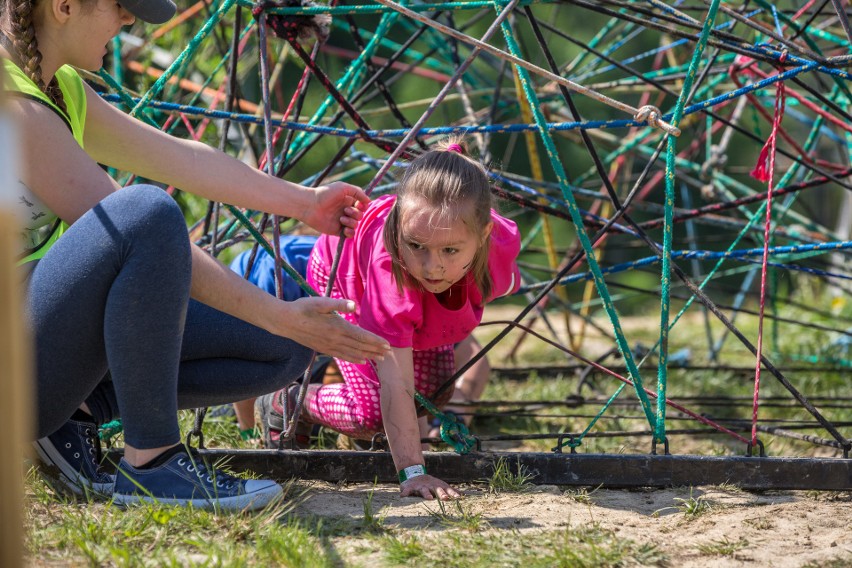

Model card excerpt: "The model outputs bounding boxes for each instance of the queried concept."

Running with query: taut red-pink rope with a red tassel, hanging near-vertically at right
[751,54,786,446]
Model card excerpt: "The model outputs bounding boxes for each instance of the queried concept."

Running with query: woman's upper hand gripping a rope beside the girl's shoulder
[299,181,370,237]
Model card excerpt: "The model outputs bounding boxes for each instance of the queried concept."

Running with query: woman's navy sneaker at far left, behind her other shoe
[33,420,115,497]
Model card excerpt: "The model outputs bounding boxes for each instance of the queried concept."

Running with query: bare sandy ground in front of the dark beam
[300,484,852,568]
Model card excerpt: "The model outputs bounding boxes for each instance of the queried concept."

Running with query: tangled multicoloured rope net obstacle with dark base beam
[95,0,852,489]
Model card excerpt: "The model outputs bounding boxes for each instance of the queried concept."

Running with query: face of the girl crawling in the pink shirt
[400,201,492,294]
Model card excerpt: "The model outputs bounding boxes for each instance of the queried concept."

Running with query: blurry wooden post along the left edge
[0,61,33,567]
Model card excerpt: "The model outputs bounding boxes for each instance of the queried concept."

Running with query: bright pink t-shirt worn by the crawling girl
[307,195,521,350]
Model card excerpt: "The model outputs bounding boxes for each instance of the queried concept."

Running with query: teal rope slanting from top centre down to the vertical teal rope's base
[494,2,655,428]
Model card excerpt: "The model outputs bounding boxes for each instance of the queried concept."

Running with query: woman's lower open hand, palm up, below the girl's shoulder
[284,297,390,364]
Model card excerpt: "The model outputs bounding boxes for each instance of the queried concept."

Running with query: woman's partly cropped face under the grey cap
[63,0,136,71]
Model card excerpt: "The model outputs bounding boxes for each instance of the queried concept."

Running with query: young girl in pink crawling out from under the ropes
[257,142,520,499]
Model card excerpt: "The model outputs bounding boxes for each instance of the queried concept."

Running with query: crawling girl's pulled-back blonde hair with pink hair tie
[383,139,494,301]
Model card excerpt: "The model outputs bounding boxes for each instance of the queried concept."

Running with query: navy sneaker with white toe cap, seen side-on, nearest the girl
[112,451,284,511]
